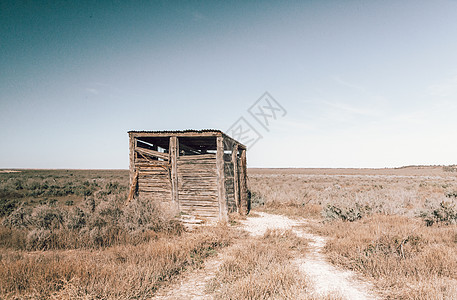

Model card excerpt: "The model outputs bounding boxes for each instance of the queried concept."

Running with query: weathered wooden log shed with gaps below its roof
[128,130,250,220]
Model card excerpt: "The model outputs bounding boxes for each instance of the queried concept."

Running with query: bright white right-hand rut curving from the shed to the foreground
[243,213,377,300]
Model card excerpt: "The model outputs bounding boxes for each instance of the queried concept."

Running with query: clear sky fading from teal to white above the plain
[0,0,457,168]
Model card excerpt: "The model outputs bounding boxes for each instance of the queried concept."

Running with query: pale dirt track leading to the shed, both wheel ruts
[153,213,377,300]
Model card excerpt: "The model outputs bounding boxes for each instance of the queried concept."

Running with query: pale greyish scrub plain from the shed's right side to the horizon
[249,168,457,217]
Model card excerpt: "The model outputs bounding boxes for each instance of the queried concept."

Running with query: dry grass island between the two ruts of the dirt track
[208,231,307,299]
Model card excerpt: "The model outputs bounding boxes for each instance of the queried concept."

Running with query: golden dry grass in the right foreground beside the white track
[312,215,457,299]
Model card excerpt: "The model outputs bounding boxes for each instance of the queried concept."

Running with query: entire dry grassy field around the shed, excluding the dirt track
[0,166,457,299]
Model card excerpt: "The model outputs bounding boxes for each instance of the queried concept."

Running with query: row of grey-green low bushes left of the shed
[1,195,183,250]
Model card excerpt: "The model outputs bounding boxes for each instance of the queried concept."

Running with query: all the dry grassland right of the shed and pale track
[249,167,457,299]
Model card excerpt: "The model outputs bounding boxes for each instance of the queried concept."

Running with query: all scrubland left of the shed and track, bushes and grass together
[0,170,234,299]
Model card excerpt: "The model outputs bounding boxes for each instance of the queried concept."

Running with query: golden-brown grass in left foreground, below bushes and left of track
[0,226,234,299]
